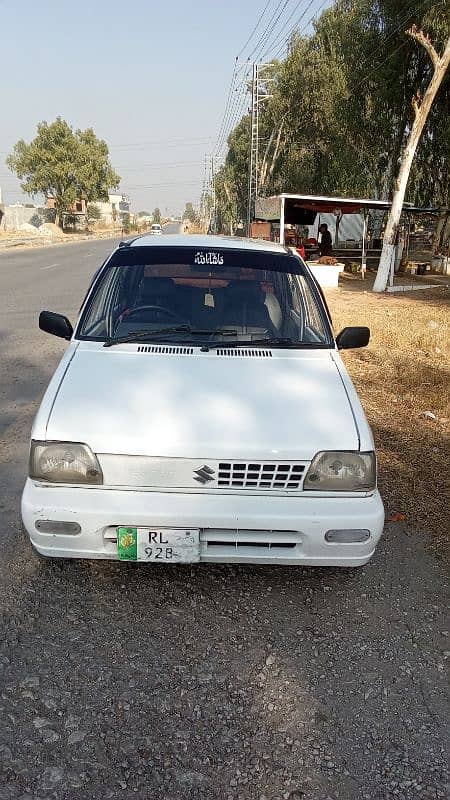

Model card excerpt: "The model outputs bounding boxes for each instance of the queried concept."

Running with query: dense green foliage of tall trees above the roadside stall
[216,0,450,230]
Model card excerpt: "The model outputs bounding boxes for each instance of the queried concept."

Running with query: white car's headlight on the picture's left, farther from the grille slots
[29,441,103,485]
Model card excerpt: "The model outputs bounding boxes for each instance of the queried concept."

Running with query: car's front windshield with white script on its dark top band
[77,245,333,347]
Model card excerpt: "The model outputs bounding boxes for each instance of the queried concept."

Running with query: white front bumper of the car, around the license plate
[22,479,384,567]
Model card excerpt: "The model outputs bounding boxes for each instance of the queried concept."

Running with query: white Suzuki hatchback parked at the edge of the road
[22,236,384,567]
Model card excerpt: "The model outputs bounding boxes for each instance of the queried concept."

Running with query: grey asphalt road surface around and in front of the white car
[0,240,450,800]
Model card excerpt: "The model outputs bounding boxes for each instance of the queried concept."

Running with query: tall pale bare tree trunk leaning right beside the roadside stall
[373,32,450,292]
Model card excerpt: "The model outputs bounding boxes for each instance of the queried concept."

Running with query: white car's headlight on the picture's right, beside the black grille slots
[303,450,377,492]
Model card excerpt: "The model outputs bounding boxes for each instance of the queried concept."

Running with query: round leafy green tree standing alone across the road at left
[6,117,120,223]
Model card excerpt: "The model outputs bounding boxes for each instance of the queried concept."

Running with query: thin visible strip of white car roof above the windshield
[122,233,288,255]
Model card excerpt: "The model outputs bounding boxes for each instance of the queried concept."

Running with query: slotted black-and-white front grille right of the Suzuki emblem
[217,461,305,489]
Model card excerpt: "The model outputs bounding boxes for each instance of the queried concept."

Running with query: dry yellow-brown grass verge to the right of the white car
[327,275,450,556]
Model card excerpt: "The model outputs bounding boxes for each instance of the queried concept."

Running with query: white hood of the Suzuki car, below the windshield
[46,342,359,460]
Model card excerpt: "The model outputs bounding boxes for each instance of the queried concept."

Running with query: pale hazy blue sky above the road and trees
[0,0,332,215]
